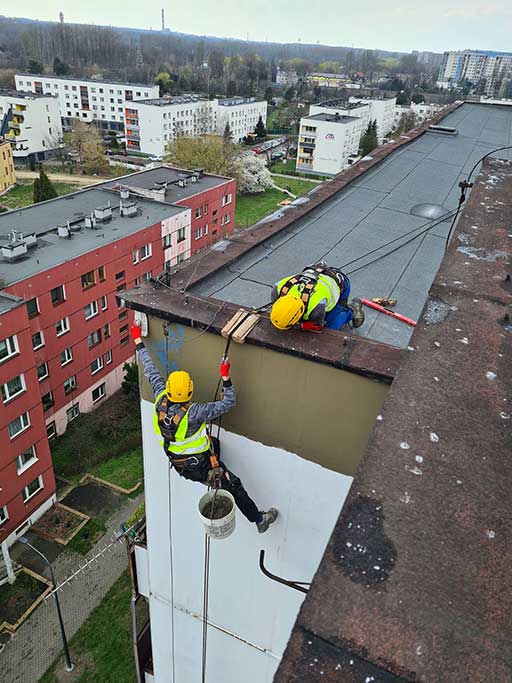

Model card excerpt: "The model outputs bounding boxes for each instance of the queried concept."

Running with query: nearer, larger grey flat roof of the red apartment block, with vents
[0,188,183,286]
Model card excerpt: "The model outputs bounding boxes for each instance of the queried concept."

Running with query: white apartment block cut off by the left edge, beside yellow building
[0,90,62,163]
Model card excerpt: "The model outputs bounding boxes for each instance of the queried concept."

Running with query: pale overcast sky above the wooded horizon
[9,0,512,52]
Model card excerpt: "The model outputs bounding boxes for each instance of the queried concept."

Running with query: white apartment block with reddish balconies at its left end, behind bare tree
[125,95,267,157]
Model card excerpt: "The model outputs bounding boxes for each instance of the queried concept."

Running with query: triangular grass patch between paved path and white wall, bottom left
[39,572,135,683]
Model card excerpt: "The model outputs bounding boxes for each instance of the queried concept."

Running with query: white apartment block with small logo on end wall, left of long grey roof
[296,112,361,176]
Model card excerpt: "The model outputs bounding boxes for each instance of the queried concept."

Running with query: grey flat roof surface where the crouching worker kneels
[192,104,512,347]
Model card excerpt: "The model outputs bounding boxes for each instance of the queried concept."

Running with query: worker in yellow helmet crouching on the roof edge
[270,262,364,332]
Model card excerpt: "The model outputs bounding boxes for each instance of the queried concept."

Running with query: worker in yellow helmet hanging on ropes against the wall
[130,323,278,534]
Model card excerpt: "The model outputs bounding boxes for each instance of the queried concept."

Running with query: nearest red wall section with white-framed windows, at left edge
[0,304,55,544]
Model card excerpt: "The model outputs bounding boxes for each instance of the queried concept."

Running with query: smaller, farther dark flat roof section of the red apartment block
[102,166,230,204]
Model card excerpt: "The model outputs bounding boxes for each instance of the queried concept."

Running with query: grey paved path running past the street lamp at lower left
[0,494,144,683]
